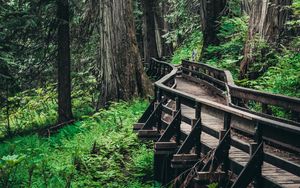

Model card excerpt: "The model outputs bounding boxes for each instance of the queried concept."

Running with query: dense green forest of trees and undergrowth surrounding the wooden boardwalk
[0,0,300,187]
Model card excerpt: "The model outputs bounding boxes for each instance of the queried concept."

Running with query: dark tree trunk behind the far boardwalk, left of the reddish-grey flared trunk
[199,0,226,49]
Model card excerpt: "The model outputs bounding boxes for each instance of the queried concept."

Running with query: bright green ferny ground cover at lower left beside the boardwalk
[0,100,153,187]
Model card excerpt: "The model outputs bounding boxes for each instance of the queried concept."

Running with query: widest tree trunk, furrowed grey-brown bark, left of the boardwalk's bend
[97,0,152,107]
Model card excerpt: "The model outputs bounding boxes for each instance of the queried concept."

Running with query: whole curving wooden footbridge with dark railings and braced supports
[134,59,300,188]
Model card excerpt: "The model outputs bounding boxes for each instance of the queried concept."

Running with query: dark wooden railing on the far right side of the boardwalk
[182,60,300,125]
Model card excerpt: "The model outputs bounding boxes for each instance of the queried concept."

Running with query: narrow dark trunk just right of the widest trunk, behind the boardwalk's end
[141,0,158,63]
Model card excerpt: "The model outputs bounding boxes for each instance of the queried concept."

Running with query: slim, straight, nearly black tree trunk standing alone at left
[57,0,73,123]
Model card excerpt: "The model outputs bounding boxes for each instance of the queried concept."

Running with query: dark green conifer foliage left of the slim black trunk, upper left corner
[0,0,55,88]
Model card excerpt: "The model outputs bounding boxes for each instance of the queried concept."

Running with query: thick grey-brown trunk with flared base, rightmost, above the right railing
[240,0,291,78]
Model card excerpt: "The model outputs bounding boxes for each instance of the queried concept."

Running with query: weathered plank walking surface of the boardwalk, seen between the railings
[168,77,300,188]
